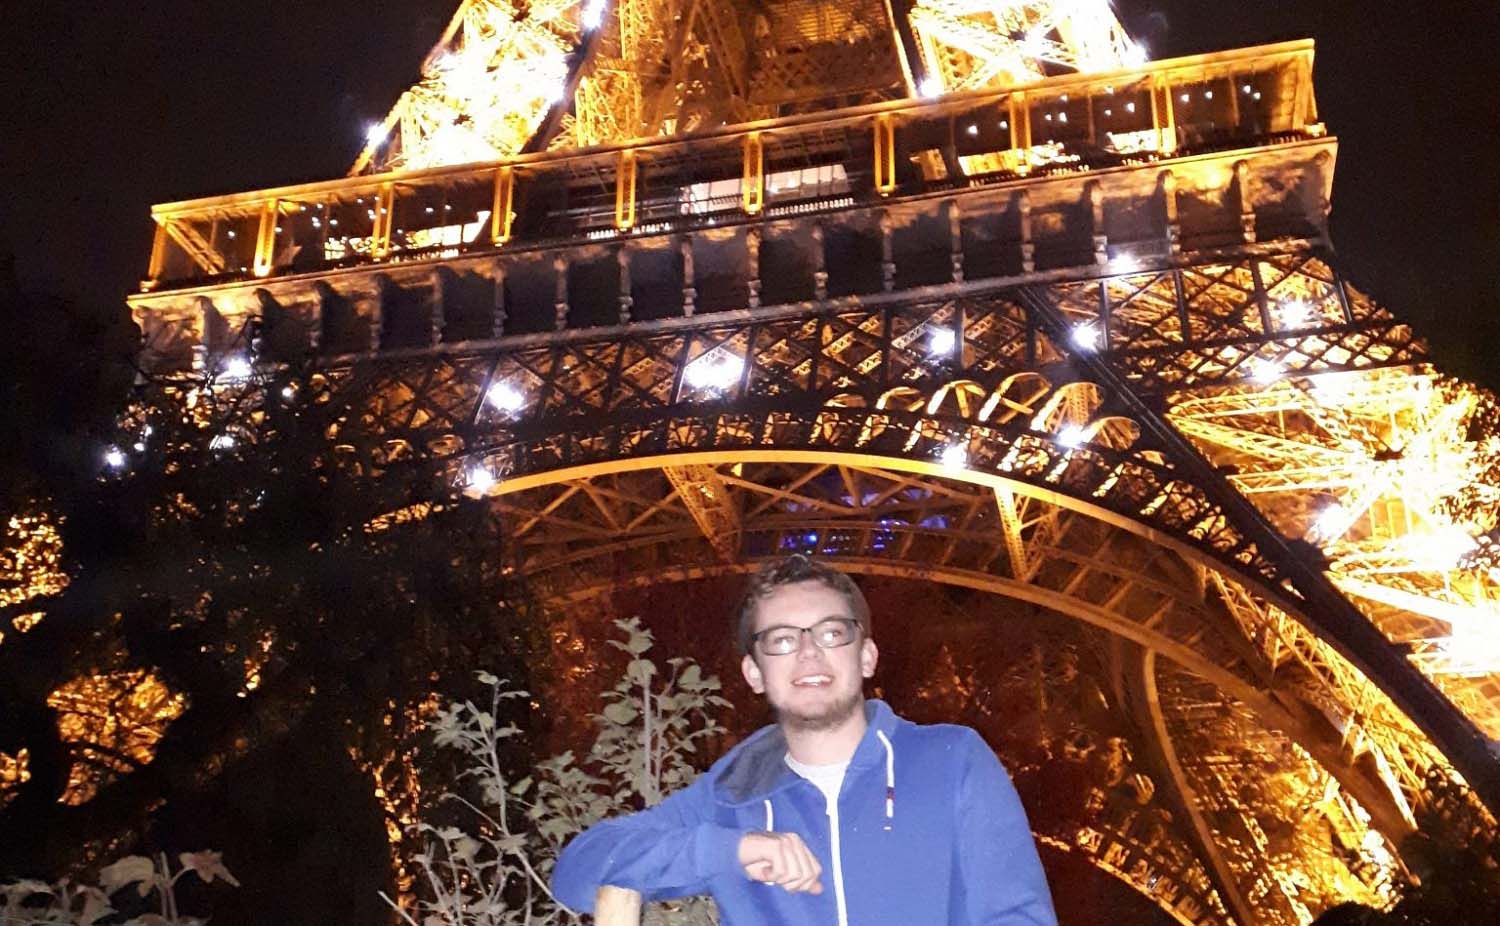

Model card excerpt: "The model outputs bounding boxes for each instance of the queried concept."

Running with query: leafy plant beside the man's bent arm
[393,618,729,926]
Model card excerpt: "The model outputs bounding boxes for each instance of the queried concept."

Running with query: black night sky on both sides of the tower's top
[0,0,1500,379]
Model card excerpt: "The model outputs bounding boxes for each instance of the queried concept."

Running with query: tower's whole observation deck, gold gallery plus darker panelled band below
[129,41,1337,369]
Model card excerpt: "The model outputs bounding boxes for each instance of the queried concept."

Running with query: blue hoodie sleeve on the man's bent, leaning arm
[552,774,744,912]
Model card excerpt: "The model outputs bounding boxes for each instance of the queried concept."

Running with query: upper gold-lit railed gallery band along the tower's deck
[143,41,1322,291]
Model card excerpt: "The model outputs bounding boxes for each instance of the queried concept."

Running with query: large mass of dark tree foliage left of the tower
[0,306,540,923]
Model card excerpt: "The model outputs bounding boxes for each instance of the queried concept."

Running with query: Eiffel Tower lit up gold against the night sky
[131,0,1500,926]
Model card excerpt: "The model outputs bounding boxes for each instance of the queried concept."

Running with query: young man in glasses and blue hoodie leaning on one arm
[552,555,1056,926]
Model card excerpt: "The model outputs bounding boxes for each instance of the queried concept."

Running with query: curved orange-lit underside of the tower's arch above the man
[498,464,1416,836]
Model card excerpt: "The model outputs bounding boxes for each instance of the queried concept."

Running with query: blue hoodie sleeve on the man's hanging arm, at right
[957,731,1058,926]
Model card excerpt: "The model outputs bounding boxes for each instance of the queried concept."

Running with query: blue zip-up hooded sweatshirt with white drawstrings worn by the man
[552,701,1058,926]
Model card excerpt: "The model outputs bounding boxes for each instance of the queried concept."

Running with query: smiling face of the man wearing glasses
[740,581,879,729]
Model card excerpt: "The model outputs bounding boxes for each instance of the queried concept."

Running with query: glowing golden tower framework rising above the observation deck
[350,0,1146,174]
